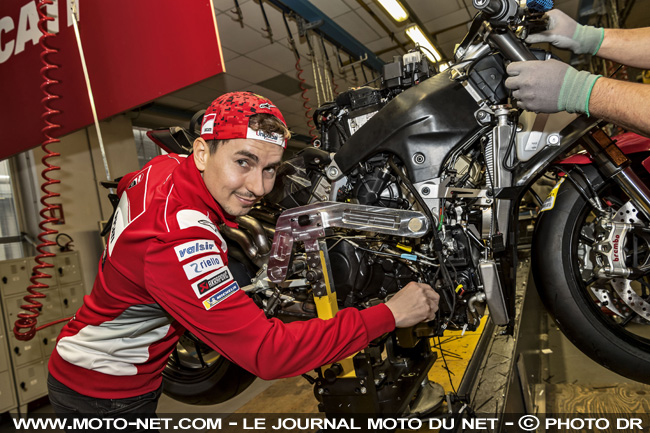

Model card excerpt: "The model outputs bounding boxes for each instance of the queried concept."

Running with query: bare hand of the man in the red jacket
[386,281,440,328]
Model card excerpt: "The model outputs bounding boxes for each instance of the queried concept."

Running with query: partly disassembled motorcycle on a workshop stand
[149,0,650,414]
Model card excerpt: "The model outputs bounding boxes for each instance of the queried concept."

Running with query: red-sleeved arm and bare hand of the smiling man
[145,229,438,379]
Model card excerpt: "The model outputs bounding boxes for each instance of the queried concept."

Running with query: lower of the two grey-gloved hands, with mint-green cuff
[505,59,601,115]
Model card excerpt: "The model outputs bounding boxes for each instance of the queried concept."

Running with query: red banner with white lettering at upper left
[0,0,224,160]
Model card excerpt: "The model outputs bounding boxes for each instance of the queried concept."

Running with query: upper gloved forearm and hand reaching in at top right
[526,9,650,69]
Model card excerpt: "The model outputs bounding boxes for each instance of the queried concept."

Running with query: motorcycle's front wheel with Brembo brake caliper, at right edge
[532,166,650,383]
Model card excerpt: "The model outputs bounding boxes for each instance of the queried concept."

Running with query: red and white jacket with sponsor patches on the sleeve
[49,154,395,398]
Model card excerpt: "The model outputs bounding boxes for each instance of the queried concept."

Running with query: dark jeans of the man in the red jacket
[47,375,162,432]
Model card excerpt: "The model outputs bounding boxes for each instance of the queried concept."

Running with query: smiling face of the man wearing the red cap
[194,138,284,216]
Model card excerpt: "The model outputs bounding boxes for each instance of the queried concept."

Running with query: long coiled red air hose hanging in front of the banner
[13,0,69,341]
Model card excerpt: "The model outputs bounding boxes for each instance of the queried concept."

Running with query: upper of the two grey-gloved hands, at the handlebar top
[526,9,605,55]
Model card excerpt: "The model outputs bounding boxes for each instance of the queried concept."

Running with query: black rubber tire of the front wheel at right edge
[531,166,650,383]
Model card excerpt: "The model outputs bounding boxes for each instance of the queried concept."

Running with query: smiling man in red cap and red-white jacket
[48,92,439,415]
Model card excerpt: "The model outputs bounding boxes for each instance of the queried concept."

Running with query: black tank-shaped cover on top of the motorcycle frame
[334,72,479,183]
